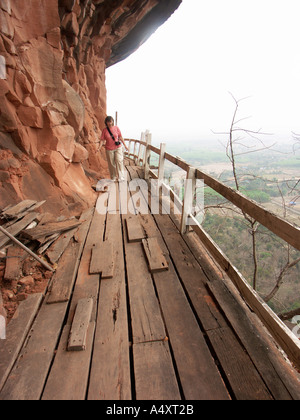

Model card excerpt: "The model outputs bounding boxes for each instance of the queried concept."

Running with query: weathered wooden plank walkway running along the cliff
[0,166,300,400]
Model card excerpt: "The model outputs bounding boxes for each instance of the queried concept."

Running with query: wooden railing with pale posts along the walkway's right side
[125,132,300,368]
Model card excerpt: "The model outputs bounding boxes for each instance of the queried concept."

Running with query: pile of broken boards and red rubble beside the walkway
[0,200,82,319]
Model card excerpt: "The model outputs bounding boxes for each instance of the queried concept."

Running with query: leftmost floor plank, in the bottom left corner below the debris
[0,293,43,390]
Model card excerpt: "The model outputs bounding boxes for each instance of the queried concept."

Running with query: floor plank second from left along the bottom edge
[0,303,68,401]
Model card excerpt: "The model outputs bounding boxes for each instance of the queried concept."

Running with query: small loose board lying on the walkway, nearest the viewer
[68,299,94,351]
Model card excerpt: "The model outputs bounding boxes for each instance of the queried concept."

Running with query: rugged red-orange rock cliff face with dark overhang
[0,0,181,213]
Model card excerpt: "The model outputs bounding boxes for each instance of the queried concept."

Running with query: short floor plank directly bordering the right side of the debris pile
[47,242,81,304]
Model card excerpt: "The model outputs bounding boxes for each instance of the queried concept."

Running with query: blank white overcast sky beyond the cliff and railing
[106,0,300,148]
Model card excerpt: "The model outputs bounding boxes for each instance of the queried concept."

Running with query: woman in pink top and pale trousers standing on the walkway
[100,117,128,181]
